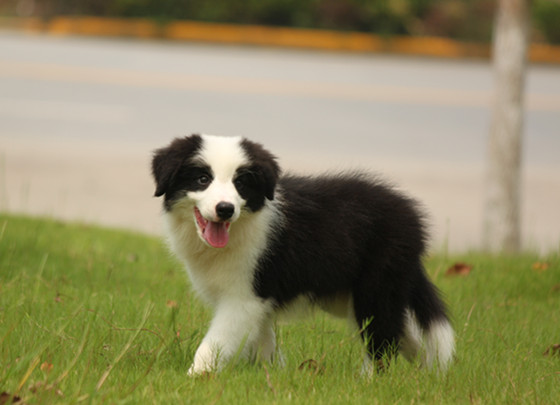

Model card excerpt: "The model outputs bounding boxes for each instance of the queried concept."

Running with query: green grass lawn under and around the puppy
[0,215,560,404]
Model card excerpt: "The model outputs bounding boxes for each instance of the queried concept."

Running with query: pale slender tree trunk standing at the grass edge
[483,0,531,252]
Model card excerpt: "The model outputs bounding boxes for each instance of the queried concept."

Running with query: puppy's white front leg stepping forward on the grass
[189,298,271,375]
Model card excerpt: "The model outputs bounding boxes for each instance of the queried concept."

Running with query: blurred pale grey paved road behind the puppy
[0,32,560,250]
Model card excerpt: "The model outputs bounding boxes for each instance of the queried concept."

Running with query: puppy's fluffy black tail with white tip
[400,277,455,371]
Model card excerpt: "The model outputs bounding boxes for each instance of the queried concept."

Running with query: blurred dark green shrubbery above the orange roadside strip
[0,0,560,43]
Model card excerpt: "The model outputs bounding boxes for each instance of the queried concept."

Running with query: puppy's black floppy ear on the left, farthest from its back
[152,135,202,197]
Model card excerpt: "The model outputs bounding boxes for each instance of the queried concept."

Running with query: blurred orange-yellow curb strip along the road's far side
[0,17,560,64]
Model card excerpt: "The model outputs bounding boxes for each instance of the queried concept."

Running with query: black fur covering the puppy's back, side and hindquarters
[254,174,446,356]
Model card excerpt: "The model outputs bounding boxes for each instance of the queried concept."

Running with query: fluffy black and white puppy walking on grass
[152,135,454,375]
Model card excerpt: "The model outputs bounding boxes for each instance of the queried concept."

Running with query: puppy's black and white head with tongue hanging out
[152,135,280,247]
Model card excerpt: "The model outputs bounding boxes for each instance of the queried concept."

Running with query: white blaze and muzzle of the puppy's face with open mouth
[188,135,248,247]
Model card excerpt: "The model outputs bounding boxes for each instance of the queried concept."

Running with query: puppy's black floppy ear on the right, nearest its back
[241,139,281,201]
